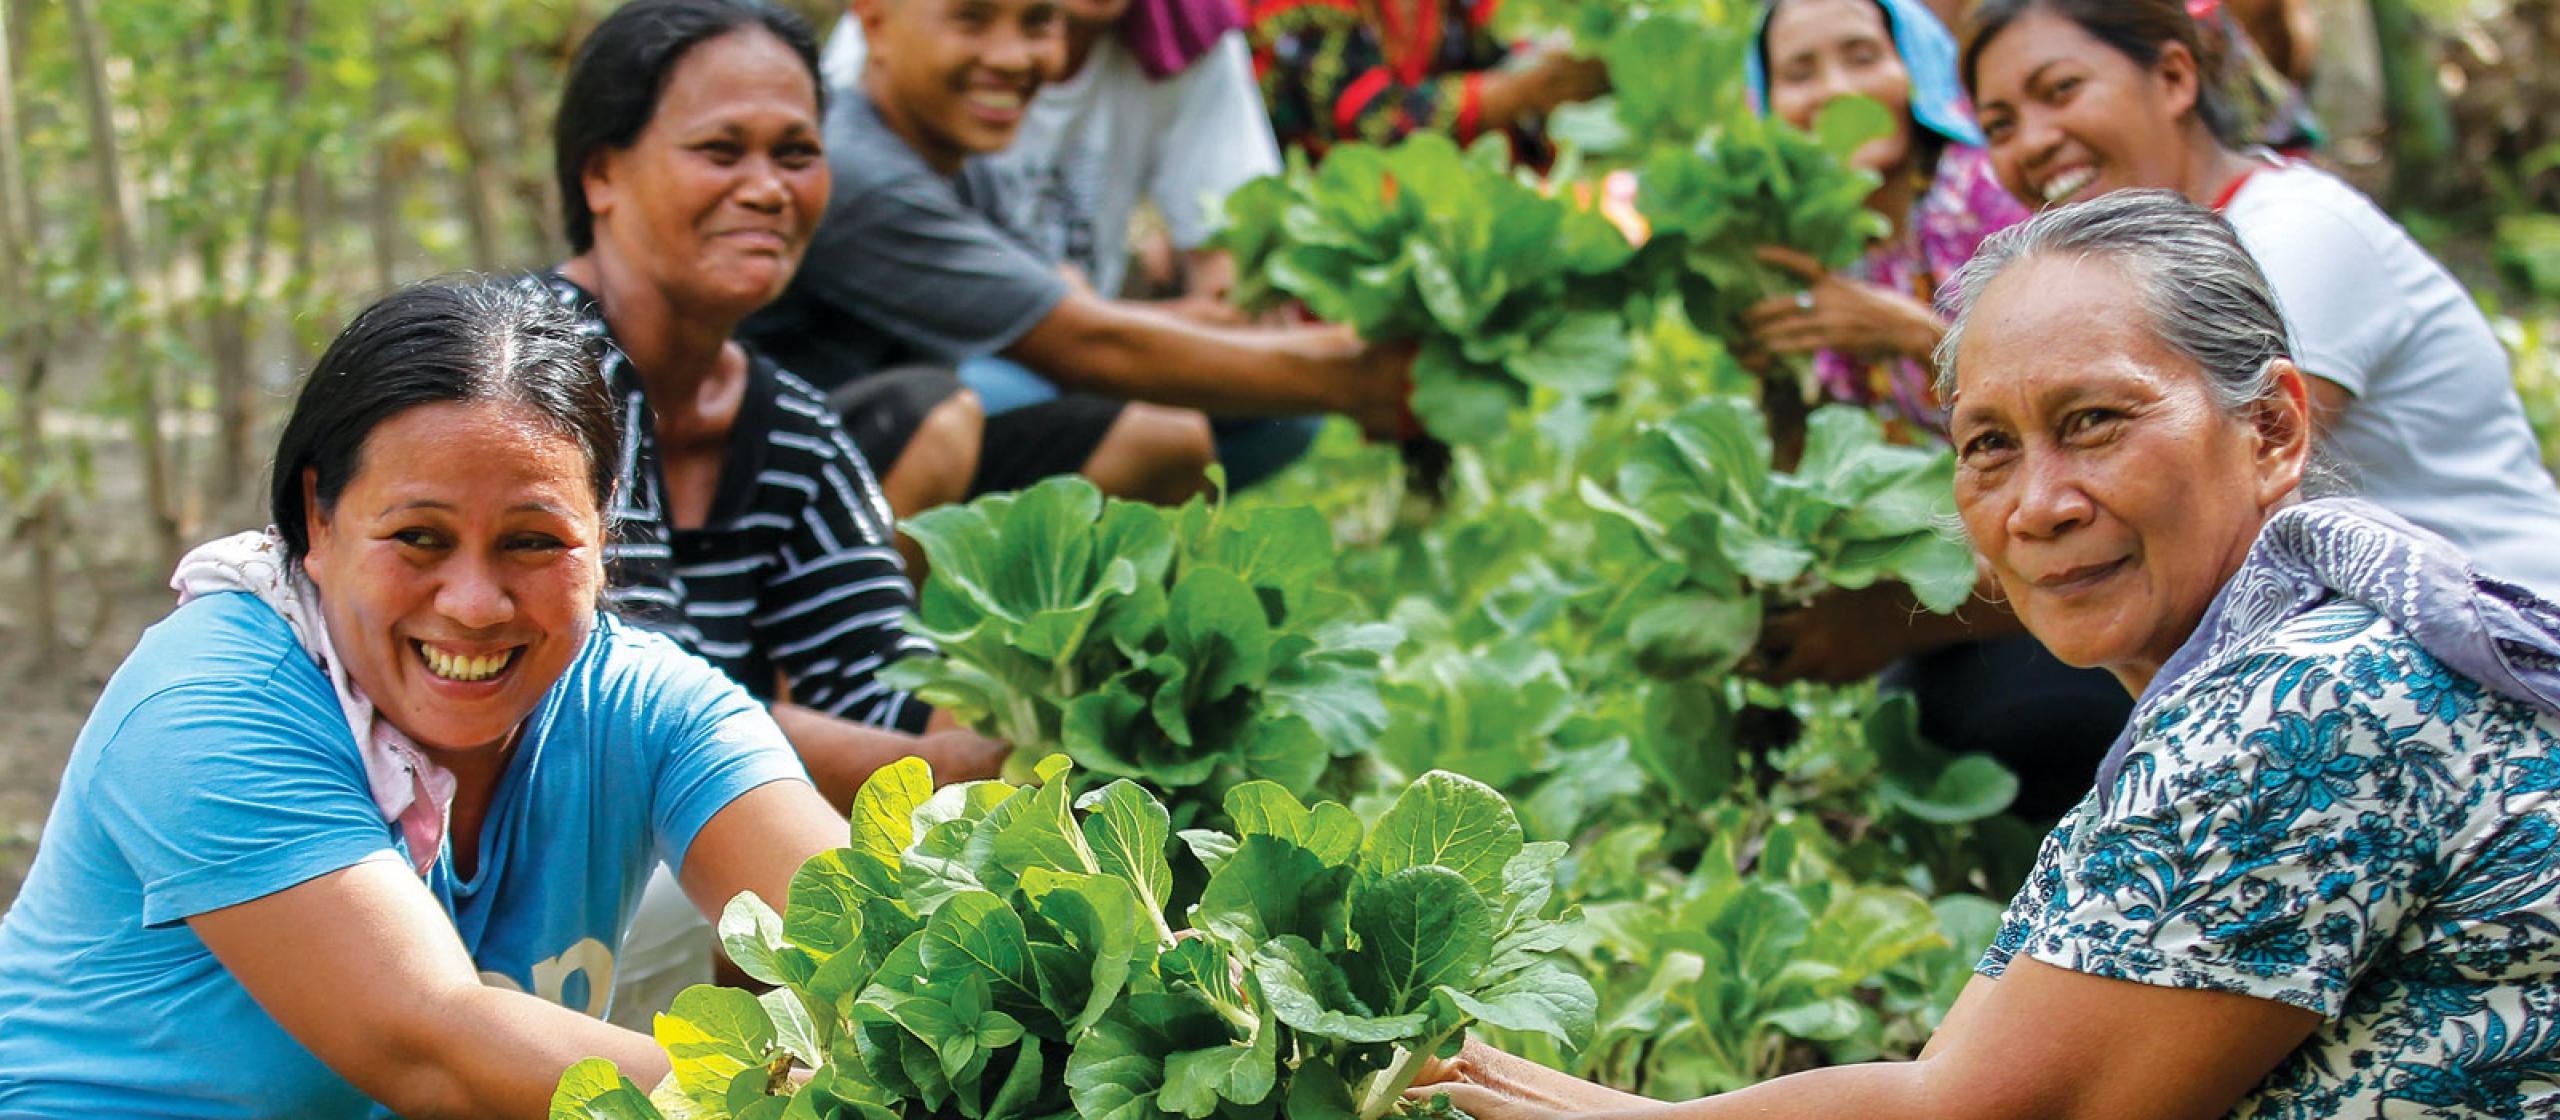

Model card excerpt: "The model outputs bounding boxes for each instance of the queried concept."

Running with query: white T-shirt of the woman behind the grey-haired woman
[2225,164,2560,596]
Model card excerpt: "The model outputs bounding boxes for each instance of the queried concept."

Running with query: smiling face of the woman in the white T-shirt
[1974,10,2212,207]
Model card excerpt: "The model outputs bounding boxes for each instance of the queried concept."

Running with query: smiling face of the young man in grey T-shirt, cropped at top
[852,0,1068,174]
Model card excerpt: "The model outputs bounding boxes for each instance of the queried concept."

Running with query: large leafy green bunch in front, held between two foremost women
[553,757,1592,1120]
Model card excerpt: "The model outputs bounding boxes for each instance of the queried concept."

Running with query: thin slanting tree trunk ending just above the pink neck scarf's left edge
[61,0,182,563]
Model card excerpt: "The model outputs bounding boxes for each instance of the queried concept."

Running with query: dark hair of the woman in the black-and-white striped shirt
[550,0,827,253]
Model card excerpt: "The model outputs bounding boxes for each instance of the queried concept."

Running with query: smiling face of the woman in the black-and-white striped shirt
[584,28,827,322]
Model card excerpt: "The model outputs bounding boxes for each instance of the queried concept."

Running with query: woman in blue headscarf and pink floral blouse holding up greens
[1746,0,2028,435]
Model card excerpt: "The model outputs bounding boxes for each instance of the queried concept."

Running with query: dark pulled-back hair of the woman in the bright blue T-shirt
[269,276,622,563]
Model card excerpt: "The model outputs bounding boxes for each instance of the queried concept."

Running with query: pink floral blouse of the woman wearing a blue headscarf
[1812,143,2033,440]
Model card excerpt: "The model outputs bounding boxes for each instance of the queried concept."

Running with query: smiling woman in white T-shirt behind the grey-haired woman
[1964,0,2560,591]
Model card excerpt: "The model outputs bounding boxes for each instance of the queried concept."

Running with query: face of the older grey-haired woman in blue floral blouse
[1951,256,2309,693]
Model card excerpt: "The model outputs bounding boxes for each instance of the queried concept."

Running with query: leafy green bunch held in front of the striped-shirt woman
[883,478,1395,823]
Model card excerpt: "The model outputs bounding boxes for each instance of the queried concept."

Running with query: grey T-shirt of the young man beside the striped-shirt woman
[740,92,1068,391]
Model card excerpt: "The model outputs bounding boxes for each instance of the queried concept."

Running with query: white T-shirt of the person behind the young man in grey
[824,18,1280,297]
